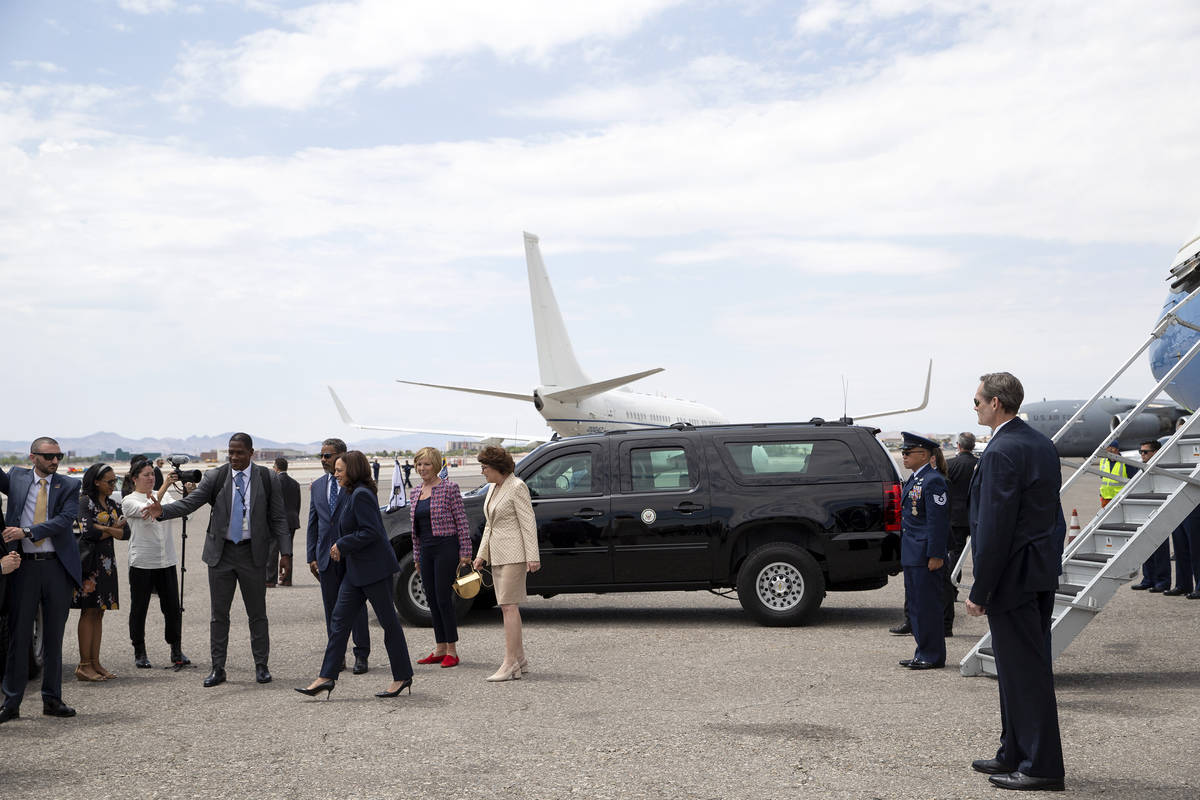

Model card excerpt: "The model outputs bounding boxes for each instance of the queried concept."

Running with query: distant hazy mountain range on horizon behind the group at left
[0,431,496,457]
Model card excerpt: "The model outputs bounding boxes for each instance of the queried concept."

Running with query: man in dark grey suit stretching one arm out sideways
[142,433,288,686]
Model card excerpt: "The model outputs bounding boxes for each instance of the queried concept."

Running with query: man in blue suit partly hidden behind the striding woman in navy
[307,439,371,675]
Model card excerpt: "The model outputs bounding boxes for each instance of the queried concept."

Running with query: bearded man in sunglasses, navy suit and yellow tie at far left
[0,437,80,723]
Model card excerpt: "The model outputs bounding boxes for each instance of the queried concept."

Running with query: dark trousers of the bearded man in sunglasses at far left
[4,557,74,709]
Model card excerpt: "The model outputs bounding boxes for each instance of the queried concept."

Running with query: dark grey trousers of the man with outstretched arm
[209,539,271,669]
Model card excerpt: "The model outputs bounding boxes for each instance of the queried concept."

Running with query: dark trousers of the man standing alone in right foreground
[988,591,1063,778]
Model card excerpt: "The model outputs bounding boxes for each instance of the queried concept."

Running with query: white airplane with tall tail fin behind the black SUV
[329,233,728,444]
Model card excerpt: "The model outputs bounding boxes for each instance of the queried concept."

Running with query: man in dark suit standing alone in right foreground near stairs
[966,372,1067,790]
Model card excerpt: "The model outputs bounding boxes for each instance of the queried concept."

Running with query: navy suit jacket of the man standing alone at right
[971,417,1067,612]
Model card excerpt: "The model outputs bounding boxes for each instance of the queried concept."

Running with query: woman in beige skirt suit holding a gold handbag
[474,445,541,681]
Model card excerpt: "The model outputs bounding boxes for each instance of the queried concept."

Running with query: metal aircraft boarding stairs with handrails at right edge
[953,290,1200,676]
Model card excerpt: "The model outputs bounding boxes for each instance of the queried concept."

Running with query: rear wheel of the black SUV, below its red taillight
[738,543,824,626]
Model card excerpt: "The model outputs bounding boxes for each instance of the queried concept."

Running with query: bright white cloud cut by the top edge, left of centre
[175,0,683,110]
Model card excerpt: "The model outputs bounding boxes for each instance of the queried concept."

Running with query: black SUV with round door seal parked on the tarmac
[384,420,900,625]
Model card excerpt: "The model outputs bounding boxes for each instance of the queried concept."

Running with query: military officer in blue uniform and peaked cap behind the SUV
[900,432,950,669]
